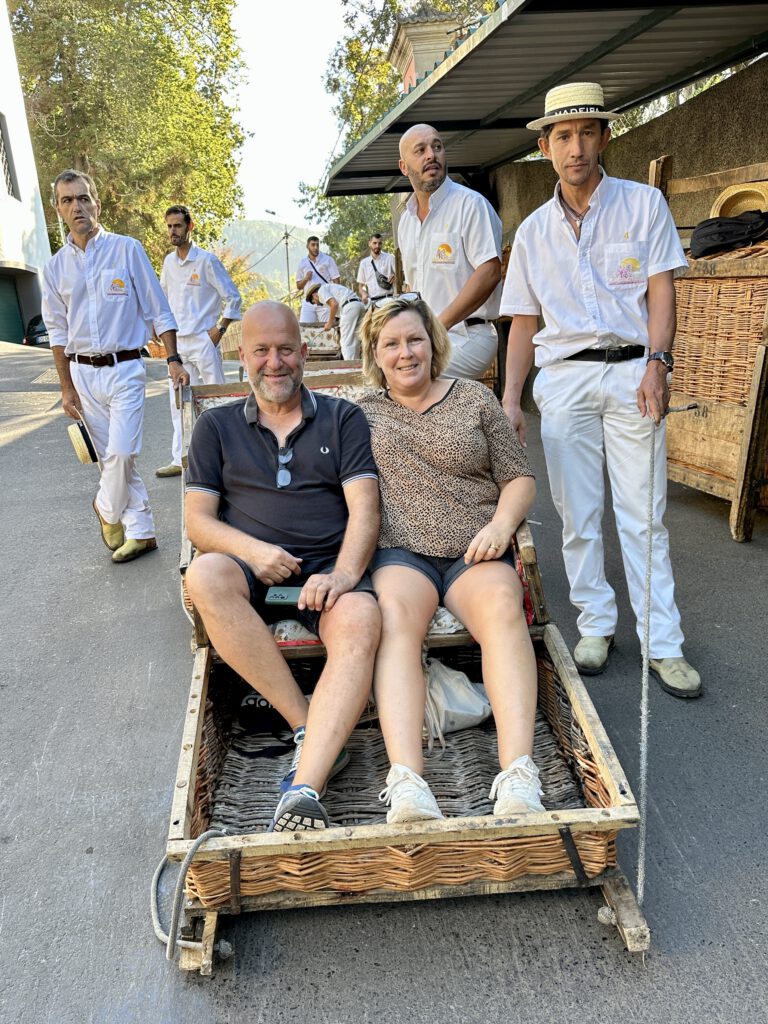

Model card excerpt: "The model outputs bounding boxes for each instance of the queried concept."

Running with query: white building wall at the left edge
[0,4,50,341]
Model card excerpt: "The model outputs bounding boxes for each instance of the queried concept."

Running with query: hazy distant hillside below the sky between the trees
[222,220,323,298]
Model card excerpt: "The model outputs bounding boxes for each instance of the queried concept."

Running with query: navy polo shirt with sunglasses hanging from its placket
[186,385,378,574]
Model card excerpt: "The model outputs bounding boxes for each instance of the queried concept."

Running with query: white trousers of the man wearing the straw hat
[534,359,683,658]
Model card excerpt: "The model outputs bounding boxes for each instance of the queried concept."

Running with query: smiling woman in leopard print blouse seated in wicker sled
[360,299,544,823]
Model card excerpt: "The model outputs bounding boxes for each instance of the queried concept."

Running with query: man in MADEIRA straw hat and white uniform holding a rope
[501,82,701,697]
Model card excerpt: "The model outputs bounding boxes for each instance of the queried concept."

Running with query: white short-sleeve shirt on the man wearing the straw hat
[501,172,687,367]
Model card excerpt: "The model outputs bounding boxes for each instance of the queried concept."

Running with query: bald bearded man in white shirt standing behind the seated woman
[397,125,502,378]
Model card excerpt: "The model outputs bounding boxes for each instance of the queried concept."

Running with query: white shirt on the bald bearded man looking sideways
[397,177,502,319]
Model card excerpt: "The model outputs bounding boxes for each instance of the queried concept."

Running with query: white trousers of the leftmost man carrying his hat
[70,359,155,541]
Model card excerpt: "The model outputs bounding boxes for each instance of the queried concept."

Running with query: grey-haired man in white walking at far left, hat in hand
[42,170,188,562]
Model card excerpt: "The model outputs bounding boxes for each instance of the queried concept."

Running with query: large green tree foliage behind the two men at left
[8,0,244,265]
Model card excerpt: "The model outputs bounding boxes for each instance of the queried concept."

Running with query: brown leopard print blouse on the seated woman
[359,380,534,558]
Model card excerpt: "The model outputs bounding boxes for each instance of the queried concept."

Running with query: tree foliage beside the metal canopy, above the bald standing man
[299,0,496,270]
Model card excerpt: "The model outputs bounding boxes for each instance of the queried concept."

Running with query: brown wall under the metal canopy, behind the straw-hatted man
[494,58,768,238]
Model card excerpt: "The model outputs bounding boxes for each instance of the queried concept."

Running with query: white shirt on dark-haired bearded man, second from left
[160,242,242,335]
